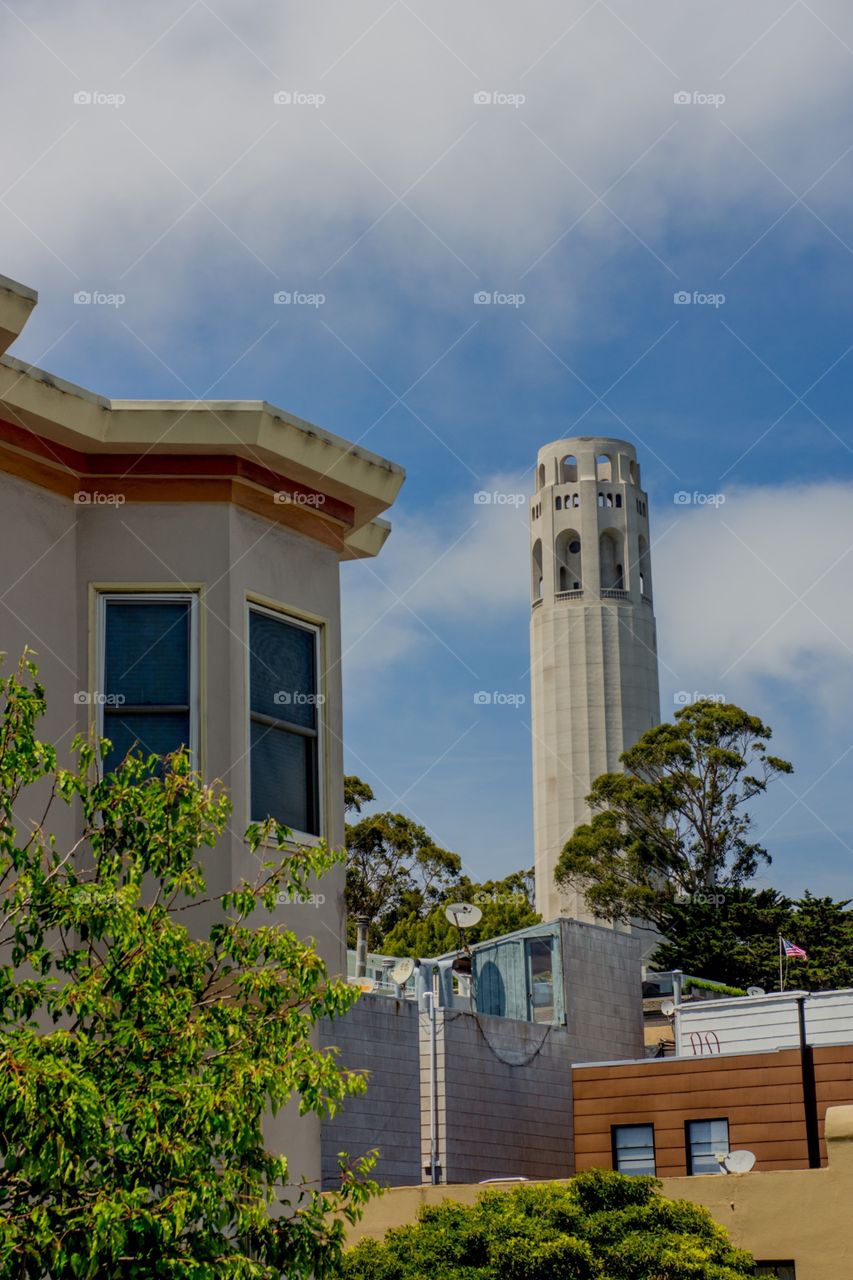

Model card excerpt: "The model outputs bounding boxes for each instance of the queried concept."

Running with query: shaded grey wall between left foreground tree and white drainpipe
[320,996,424,1187]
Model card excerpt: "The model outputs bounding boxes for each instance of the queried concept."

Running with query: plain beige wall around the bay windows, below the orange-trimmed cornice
[0,474,346,1178]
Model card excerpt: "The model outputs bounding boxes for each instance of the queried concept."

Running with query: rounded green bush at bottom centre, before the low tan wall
[341,1170,753,1280]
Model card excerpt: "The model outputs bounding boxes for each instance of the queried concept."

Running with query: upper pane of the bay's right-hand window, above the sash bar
[248,612,316,732]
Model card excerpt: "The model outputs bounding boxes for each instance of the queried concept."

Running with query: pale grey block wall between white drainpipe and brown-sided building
[432,1011,574,1183]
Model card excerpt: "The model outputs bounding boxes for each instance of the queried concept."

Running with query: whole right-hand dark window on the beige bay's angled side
[248,609,321,836]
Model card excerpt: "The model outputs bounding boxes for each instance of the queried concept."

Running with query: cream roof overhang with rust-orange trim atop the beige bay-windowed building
[0,276,405,558]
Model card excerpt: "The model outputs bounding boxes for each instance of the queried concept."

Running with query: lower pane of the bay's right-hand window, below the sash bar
[251,723,320,836]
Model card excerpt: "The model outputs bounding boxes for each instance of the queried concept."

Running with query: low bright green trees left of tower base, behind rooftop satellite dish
[383,872,542,956]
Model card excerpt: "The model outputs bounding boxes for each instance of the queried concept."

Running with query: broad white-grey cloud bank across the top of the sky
[0,0,853,355]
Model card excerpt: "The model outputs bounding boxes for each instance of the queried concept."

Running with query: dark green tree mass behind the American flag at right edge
[652,888,853,991]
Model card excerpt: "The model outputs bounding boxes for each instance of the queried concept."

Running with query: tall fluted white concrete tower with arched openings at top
[530,435,661,920]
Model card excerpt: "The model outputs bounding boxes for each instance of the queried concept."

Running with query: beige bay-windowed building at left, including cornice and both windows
[0,270,403,1178]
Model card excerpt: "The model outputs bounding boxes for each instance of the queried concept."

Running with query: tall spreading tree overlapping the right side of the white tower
[556,700,793,931]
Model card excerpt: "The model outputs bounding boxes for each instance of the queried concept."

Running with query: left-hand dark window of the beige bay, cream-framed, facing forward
[96,595,195,771]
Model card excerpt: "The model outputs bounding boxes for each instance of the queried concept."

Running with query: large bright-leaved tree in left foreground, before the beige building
[0,660,373,1280]
